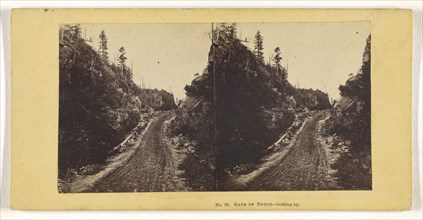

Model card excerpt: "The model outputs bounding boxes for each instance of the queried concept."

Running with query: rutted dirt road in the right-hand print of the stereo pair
[247,113,334,190]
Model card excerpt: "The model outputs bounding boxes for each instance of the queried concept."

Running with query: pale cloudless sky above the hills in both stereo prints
[81,22,370,99]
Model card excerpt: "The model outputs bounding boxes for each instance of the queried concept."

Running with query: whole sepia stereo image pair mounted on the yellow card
[56,21,372,193]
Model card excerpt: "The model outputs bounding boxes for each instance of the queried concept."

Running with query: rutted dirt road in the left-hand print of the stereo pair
[92,114,178,192]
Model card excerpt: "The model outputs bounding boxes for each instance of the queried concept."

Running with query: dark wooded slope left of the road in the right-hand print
[212,36,294,169]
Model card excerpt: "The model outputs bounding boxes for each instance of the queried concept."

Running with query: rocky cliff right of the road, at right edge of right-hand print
[326,36,372,189]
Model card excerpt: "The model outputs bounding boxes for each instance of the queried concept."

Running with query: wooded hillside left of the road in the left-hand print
[59,25,176,178]
